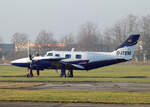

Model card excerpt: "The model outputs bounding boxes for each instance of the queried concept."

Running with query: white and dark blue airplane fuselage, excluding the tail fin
[12,51,127,70]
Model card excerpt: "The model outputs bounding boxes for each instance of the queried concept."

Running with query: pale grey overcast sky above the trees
[0,0,150,43]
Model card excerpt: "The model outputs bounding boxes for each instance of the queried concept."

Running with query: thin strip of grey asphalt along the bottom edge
[0,102,150,107]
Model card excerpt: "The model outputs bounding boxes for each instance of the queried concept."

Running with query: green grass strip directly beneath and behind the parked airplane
[0,63,150,83]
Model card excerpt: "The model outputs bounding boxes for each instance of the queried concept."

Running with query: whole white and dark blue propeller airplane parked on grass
[11,34,140,77]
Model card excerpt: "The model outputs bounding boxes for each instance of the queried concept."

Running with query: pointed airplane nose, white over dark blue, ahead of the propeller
[11,58,30,67]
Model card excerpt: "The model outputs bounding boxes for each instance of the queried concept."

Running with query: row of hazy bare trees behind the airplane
[0,15,150,61]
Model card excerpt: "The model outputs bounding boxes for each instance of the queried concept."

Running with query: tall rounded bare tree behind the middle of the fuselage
[77,22,101,51]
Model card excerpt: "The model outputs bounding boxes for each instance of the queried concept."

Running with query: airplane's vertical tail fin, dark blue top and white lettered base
[113,34,140,60]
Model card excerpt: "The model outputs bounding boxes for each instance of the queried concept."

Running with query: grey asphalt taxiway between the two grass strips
[22,82,150,92]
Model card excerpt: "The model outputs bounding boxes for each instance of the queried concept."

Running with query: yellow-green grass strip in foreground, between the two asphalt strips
[0,89,150,104]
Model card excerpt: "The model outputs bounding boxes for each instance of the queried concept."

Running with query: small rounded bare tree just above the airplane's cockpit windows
[35,30,56,54]
